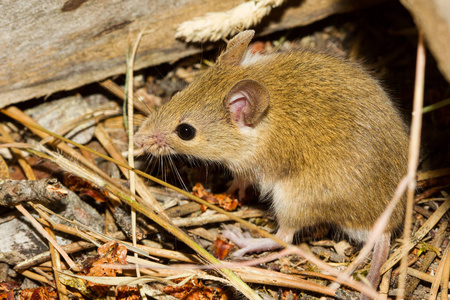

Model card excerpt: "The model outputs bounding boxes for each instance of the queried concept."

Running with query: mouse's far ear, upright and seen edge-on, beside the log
[217,30,255,66]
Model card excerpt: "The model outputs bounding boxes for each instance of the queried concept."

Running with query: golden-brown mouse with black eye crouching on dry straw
[135,30,409,296]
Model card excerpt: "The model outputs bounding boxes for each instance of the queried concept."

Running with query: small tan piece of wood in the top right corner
[400,0,450,82]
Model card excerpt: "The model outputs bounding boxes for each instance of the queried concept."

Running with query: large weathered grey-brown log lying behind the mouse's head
[0,0,383,108]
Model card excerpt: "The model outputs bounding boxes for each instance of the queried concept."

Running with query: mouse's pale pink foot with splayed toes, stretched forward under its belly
[222,225,282,257]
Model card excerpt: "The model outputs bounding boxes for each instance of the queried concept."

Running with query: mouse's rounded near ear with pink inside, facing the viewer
[224,79,270,127]
